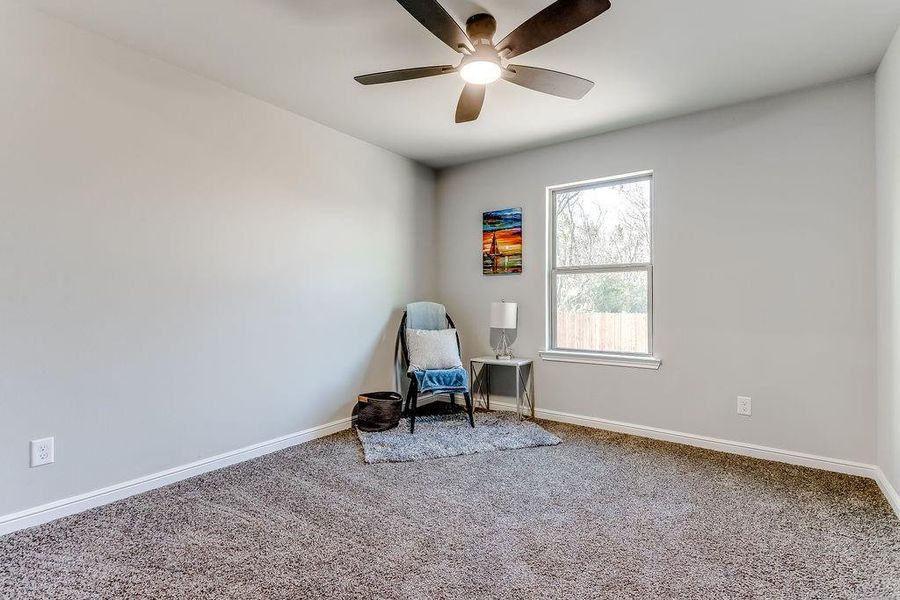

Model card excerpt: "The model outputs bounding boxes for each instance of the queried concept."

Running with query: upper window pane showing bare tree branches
[554,178,650,267]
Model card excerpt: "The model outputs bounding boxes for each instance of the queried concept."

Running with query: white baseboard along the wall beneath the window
[491,402,884,480]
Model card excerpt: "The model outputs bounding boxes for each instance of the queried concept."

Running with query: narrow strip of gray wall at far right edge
[876,31,900,490]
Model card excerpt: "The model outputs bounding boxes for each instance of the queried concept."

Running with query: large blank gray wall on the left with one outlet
[0,0,434,514]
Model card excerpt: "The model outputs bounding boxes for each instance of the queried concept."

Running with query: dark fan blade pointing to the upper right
[496,0,612,59]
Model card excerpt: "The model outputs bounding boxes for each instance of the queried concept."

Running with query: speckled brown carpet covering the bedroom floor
[0,406,900,600]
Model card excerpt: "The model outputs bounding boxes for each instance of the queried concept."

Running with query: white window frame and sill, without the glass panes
[540,171,660,369]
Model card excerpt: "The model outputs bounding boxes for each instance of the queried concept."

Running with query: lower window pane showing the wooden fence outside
[555,271,649,354]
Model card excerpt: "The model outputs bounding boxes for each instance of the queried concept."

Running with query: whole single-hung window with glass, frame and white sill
[542,173,659,368]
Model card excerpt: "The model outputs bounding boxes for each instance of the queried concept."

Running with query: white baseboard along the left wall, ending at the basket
[0,417,351,535]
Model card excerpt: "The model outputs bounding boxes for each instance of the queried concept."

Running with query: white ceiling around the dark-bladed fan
[29,0,900,167]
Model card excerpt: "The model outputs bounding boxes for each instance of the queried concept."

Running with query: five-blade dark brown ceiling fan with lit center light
[354,0,611,123]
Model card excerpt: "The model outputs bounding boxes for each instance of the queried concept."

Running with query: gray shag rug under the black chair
[356,411,560,463]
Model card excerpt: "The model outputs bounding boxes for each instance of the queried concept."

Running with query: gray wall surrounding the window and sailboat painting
[437,77,875,463]
